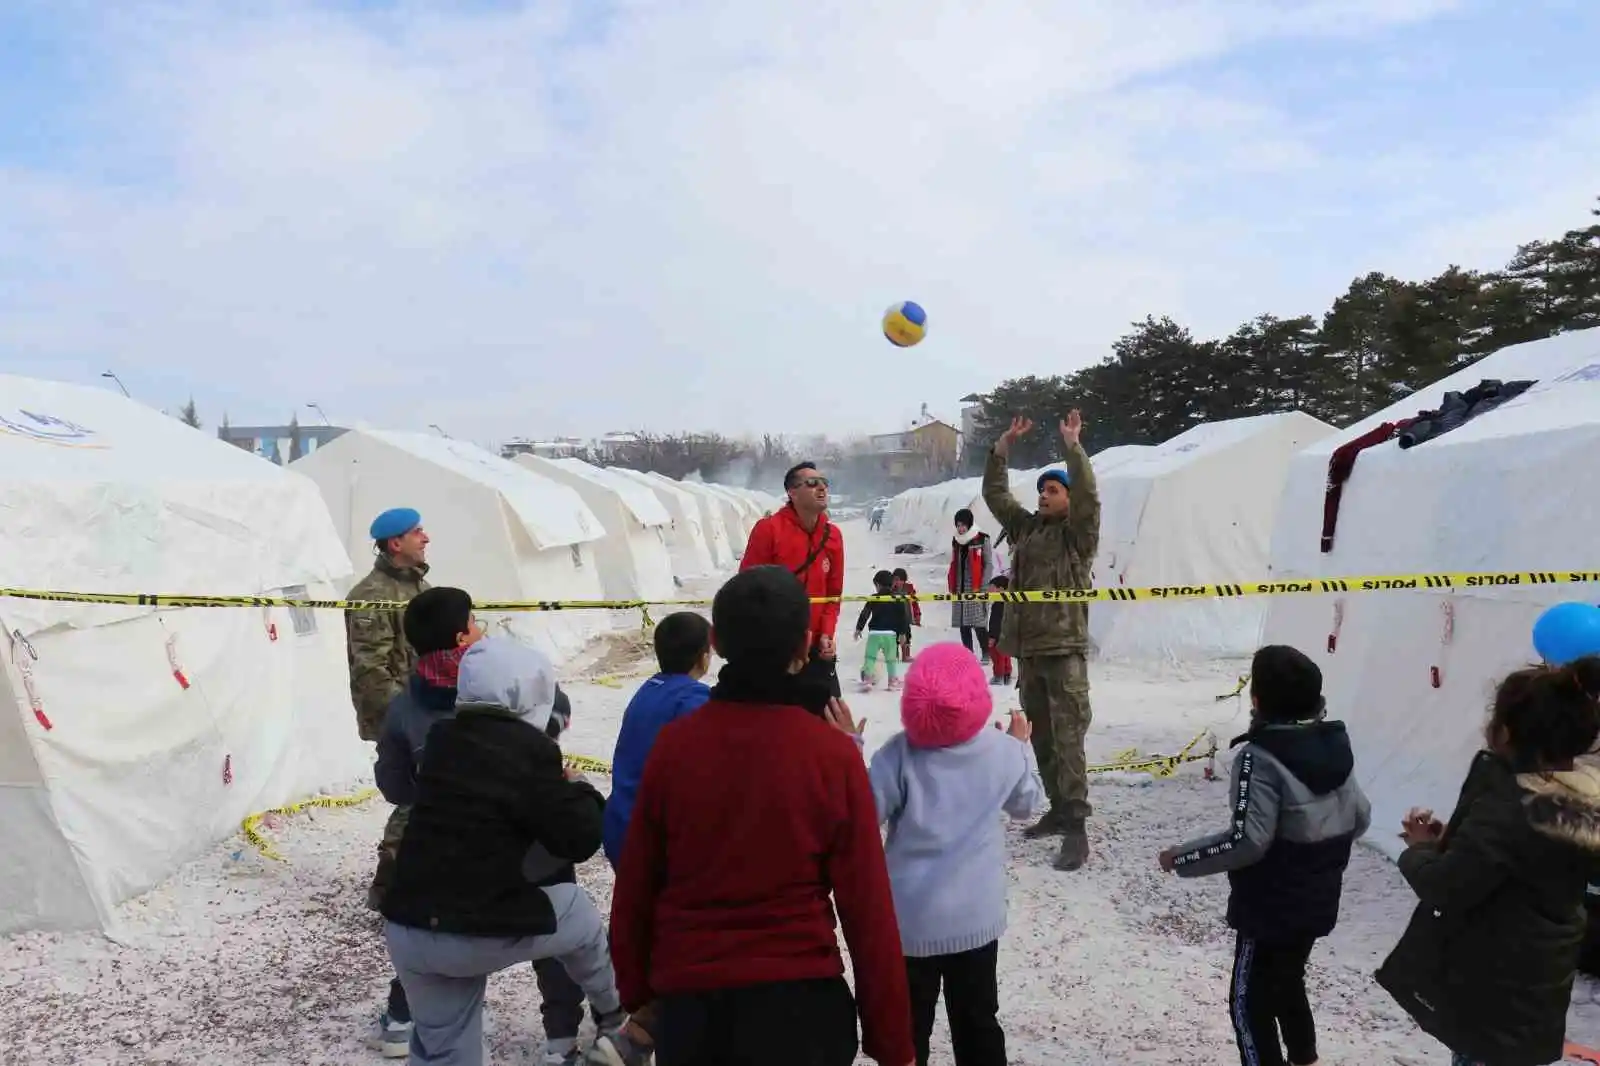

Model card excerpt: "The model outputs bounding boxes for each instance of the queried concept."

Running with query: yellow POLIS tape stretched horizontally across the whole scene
[0,570,1600,616]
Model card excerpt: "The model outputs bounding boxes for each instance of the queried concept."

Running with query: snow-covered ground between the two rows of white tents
[9,512,1600,1066]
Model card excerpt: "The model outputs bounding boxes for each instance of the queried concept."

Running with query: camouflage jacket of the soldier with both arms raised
[984,445,1099,658]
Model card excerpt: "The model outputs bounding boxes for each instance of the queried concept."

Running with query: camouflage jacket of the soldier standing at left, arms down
[344,555,427,741]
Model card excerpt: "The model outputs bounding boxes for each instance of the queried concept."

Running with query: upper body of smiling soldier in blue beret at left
[344,507,427,741]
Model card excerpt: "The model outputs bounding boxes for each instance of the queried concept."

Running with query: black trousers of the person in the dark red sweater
[656,978,859,1066]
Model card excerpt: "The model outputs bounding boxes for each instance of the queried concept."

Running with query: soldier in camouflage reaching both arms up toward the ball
[984,411,1099,871]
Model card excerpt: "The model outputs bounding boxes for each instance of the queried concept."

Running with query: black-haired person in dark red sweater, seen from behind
[611,567,915,1066]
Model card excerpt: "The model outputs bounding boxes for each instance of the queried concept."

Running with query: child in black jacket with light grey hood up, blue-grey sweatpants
[384,637,643,1066]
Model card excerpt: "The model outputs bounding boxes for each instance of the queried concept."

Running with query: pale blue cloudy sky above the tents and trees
[0,0,1600,440]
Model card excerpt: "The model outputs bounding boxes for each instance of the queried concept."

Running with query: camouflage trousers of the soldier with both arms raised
[1018,651,1093,818]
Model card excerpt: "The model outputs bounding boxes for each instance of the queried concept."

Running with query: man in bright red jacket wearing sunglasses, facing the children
[739,463,845,696]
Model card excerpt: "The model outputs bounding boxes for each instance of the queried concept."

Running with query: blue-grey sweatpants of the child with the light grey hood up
[384,885,622,1066]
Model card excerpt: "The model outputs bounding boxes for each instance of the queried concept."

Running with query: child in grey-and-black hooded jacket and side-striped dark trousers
[1162,645,1371,1066]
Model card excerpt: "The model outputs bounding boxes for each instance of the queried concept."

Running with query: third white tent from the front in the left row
[517,455,674,600]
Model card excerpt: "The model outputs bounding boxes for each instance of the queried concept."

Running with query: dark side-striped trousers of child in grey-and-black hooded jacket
[1227,933,1317,1066]
